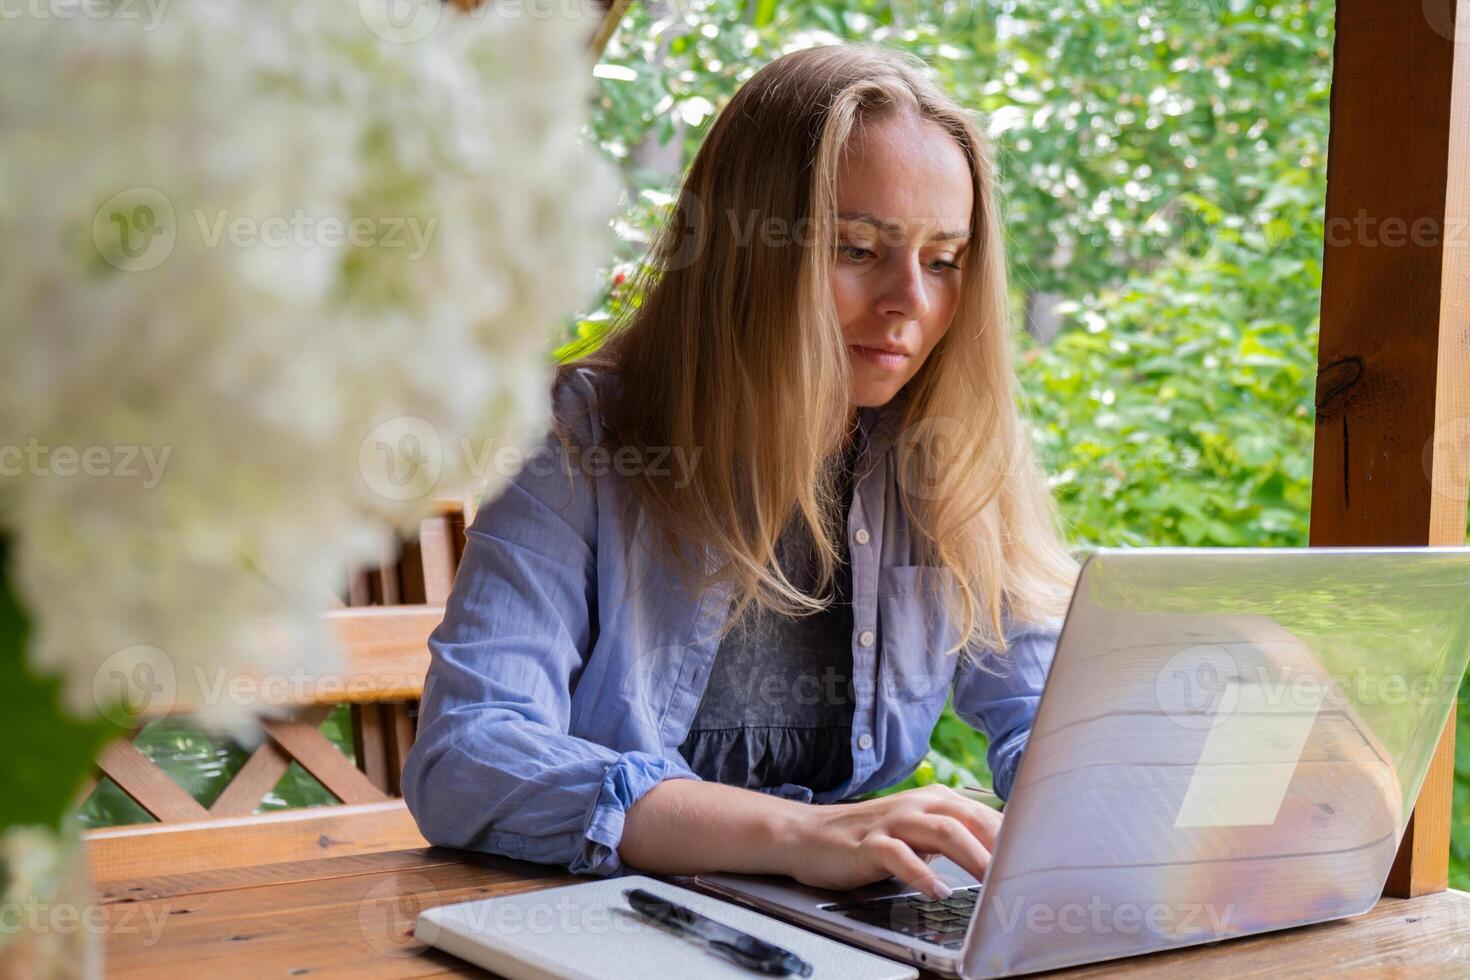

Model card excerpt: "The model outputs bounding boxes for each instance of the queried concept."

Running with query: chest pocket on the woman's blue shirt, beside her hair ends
[878,564,958,702]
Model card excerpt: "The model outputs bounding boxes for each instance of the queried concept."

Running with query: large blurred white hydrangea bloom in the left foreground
[0,0,617,733]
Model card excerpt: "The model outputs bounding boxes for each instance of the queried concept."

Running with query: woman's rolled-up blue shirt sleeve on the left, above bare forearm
[403,379,697,874]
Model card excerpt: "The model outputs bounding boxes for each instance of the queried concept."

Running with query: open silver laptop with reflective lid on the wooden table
[692,548,1470,979]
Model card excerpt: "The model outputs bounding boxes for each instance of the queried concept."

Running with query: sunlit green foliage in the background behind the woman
[582,0,1470,886]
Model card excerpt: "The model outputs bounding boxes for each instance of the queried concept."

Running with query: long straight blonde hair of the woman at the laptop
[557,44,1078,664]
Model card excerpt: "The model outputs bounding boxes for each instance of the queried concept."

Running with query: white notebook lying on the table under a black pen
[413,874,919,980]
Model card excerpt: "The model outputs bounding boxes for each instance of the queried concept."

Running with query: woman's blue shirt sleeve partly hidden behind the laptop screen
[954,623,1060,799]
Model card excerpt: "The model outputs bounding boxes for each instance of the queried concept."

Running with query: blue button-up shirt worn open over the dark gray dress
[403,367,1060,874]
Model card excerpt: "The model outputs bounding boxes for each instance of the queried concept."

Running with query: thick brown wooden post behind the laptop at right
[1311,0,1470,896]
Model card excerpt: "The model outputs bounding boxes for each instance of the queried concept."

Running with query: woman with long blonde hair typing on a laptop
[404,46,1076,895]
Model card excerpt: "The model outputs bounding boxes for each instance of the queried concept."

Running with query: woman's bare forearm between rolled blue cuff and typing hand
[617,779,811,874]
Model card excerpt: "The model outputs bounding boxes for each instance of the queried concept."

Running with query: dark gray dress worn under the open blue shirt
[679,438,861,792]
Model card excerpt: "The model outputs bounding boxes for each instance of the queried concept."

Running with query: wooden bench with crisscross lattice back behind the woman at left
[79,501,472,883]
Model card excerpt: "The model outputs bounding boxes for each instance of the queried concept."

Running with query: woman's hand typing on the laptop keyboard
[782,785,1001,898]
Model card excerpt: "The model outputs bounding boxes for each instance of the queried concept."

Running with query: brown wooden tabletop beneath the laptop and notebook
[97,848,1470,980]
